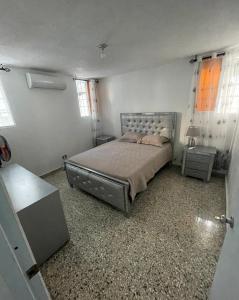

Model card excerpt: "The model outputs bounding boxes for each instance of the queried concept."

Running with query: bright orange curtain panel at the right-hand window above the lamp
[196,58,222,112]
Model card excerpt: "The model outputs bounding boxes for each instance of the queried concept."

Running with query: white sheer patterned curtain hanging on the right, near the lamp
[187,48,239,171]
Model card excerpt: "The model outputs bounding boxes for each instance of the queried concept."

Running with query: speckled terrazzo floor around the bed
[41,167,225,300]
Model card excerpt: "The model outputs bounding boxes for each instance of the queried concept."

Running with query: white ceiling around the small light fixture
[0,0,239,78]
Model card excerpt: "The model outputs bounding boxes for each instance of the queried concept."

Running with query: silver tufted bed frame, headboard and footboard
[64,112,177,216]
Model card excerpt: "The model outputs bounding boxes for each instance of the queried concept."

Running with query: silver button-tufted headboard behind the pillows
[120,112,177,143]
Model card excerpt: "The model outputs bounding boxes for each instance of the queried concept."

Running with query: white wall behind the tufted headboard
[99,59,193,163]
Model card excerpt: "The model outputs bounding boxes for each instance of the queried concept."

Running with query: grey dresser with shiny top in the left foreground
[0,164,69,265]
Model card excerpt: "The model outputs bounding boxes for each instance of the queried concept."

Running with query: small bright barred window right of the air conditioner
[76,80,90,117]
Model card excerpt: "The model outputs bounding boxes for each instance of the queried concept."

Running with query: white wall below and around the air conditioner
[0,69,92,175]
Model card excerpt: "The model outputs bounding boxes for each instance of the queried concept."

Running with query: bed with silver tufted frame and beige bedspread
[64,112,176,215]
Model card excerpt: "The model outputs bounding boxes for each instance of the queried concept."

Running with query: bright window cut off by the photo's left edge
[0,83,15,127]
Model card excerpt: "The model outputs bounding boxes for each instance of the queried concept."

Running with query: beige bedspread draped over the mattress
[69,140,172,200]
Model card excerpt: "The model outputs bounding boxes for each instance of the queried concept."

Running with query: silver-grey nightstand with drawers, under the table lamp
[182,146,217,182]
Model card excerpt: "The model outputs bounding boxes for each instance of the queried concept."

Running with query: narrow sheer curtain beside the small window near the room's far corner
[88,80,101,146]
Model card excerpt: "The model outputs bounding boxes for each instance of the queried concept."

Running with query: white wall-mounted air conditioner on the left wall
[26,73,66,90]
